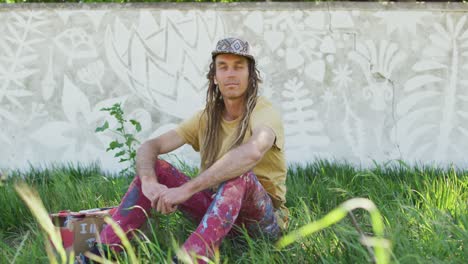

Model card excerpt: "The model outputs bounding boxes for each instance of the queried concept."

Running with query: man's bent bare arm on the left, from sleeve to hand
[136,130,185,206]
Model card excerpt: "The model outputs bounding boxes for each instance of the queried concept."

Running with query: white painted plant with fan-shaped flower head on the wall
[345,40,406,160]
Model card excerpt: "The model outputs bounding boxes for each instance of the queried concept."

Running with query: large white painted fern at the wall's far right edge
[395,15,468,161]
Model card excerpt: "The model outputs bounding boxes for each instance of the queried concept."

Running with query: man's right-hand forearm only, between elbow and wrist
[185,144,262,193]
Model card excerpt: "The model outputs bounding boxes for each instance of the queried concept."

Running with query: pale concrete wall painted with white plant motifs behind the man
[0,2,468,170]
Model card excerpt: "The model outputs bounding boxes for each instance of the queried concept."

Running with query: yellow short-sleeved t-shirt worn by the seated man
[176,97,289,228]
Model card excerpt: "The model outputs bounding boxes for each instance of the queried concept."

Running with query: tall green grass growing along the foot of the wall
[0,161,468,264]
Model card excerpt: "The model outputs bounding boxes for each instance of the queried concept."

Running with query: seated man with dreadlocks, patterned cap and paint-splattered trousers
[78,38,288,261]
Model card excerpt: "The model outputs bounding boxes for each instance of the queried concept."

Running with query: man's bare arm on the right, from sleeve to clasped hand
[157,126,276,213]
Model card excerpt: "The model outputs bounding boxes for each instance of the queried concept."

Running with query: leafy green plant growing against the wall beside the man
[95,103,141,174]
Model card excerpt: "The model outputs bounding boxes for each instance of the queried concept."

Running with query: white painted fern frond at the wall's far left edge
[0,11,48,143]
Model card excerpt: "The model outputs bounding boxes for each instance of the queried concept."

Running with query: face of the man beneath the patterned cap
[214,54,249,99]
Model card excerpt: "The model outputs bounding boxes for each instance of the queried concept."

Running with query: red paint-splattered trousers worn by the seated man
[101,160,281,257]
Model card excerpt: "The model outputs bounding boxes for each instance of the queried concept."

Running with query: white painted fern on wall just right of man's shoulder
[282,78,330,161]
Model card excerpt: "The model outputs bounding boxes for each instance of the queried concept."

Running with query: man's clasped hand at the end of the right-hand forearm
[155,186,193,214]
